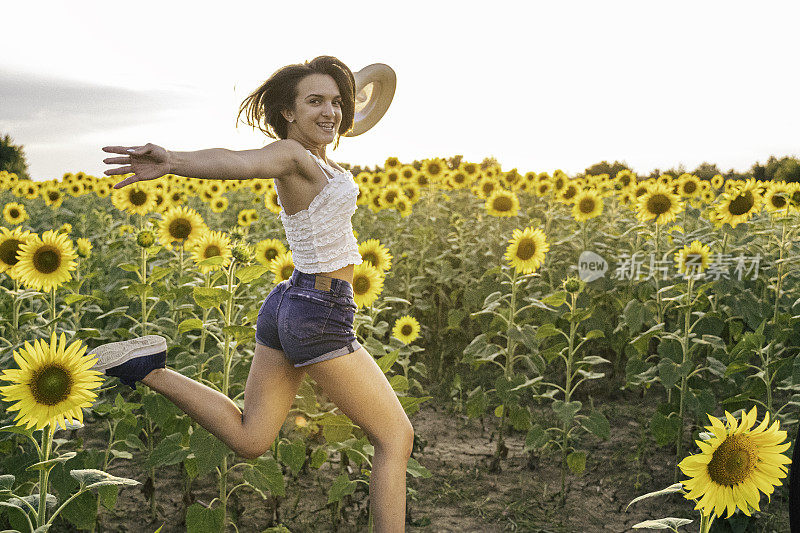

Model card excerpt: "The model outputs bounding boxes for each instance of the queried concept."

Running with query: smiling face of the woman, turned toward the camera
[284,74,342,146]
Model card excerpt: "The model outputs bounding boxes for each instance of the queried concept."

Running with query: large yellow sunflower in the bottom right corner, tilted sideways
[678,406,792,518]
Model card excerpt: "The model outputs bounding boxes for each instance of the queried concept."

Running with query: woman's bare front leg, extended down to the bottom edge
[301,347,414,533]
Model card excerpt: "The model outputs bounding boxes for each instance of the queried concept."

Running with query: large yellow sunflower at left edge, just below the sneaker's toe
[0,332,103,429]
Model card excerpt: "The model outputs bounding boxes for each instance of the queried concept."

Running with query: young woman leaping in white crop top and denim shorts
[93,56,414,532]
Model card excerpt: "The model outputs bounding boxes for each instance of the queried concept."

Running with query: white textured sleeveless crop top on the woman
[278,150,363,274]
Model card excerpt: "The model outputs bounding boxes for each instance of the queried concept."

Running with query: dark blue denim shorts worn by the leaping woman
[256,269,361,367]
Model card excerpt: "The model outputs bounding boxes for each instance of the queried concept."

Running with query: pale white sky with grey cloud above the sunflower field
[0,0,800,179]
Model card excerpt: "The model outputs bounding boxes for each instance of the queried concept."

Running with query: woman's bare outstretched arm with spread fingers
[103,139,305,189]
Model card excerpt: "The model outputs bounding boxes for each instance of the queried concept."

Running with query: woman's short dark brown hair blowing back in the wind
[236,56,356,149]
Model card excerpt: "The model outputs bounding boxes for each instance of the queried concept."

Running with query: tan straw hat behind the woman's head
[345,63,397,137]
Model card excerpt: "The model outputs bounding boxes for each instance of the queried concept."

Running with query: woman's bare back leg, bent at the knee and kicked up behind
[142,343,305,459]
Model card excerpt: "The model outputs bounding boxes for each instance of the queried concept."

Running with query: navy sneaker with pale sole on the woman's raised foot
[89,335,167,389]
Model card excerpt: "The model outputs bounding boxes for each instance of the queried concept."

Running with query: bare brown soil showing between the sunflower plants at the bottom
[45,393,789,533]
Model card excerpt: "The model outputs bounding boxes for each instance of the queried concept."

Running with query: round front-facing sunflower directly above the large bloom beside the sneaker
[16,230,77,291]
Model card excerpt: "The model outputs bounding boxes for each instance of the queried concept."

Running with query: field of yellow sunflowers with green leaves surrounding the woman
[0,156,800,532]
